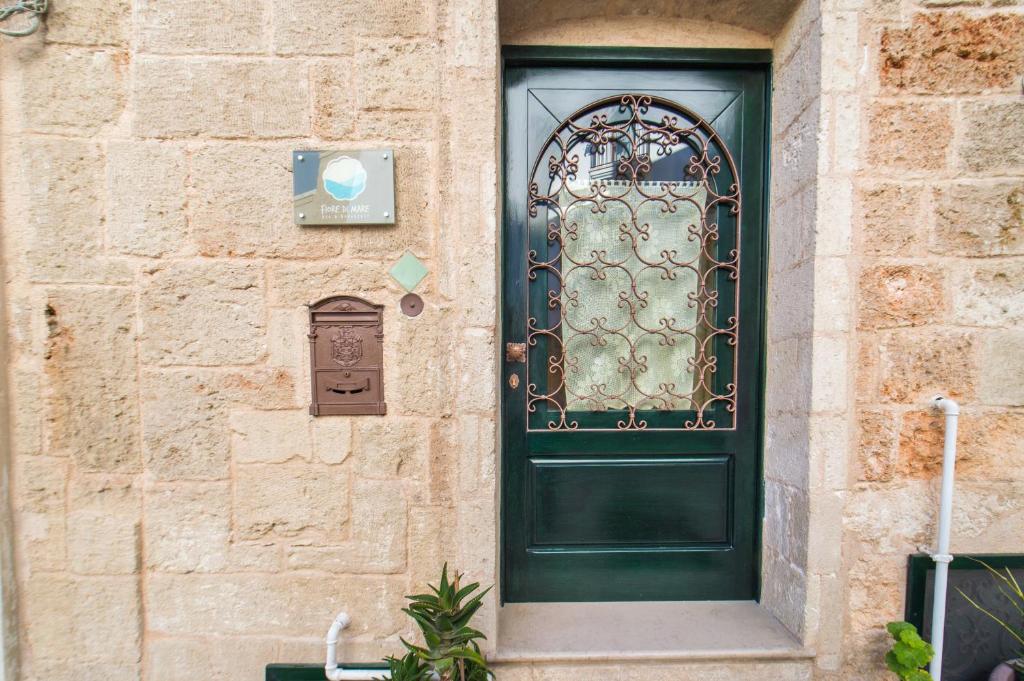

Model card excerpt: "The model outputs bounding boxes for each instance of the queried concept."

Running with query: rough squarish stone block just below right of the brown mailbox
[351,417,430,479]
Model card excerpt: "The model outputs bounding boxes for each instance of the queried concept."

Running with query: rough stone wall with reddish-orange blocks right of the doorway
[837,0,1024,679]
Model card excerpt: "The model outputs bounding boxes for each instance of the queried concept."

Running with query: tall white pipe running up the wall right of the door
[928,395,959,681]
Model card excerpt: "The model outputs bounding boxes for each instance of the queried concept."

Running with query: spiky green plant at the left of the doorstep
[387,563,494,681]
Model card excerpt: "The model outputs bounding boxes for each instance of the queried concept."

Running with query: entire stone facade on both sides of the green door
[0,0,1024,681]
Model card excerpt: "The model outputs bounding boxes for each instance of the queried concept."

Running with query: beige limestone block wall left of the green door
[2,0,498,681]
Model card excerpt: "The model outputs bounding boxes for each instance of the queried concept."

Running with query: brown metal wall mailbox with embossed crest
[309,296,387,416]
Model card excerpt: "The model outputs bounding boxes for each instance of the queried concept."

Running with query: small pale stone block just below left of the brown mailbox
[230,410,312,464]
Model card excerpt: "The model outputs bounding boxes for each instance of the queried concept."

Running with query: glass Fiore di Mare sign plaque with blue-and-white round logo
[292,148,394,224]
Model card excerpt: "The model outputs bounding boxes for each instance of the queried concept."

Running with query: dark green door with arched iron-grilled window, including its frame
[501,48,768,601]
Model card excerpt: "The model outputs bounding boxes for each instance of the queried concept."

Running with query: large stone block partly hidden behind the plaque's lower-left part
[188,144,346,258]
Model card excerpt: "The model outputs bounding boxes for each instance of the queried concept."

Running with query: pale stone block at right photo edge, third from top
[931,181,1024,257]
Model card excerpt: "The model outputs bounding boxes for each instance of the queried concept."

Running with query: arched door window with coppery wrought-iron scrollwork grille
[526,94,740,430]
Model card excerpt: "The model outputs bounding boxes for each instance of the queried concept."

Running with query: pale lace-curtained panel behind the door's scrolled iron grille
[559,180,707,412]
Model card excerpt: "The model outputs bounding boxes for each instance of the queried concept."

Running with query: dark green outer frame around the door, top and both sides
[496,45,772,605]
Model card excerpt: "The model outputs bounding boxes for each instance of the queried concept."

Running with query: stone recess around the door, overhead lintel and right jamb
[498,0,859,671]
